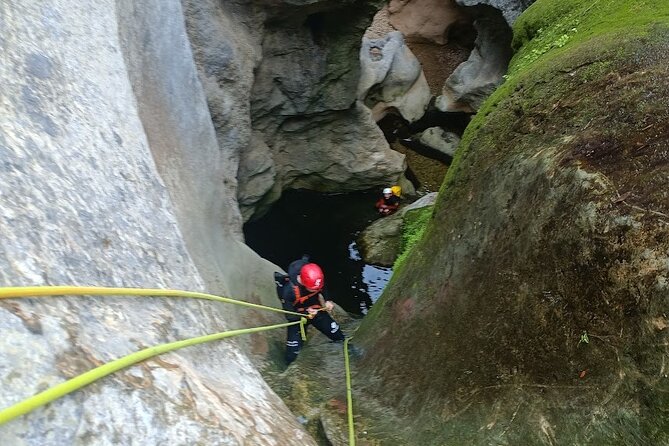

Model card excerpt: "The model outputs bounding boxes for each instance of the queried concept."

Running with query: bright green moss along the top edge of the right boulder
[394,0,669,286]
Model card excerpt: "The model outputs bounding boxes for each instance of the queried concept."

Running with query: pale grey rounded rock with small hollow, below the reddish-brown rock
[358,31,432,122]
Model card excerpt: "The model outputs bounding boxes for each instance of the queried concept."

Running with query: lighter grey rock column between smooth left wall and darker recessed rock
[182,0,264,223]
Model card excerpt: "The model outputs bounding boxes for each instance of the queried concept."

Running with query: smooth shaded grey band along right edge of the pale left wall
[117,1,282,361]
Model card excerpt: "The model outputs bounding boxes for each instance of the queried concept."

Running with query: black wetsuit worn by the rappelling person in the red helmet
[283,258,344,364]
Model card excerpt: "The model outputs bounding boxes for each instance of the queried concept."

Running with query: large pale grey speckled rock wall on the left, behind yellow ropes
[0,0,314,445]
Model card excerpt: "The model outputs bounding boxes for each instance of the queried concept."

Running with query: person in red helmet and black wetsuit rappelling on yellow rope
[281,256,345,364]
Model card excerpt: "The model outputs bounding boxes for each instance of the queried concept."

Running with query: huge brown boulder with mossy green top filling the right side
[355,0,669,445]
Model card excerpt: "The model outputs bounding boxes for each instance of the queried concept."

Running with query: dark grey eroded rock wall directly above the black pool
[177,0,405,220]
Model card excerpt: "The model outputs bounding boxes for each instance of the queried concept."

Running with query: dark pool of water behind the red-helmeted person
[244,190,392,314]
